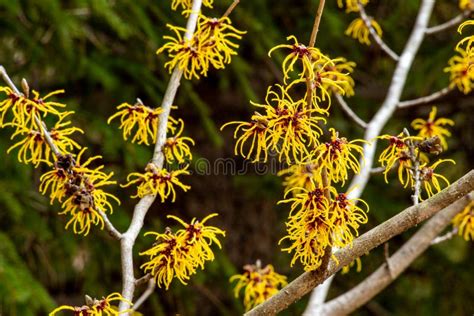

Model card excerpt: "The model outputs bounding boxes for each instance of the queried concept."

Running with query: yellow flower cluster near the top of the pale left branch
[156,15,245,79]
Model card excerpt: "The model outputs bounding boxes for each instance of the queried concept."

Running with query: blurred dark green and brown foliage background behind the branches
[0,0,474,316]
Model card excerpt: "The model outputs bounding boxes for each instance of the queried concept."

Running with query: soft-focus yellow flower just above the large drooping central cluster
[278,163,322,195]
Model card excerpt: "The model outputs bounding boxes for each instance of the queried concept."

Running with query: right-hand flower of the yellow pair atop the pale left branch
[194,15,247,64]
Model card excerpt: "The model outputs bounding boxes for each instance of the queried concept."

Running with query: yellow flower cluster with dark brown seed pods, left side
[39,148,120,236]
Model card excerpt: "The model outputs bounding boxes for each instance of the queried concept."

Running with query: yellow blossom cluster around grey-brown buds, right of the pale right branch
[379,107,455,198]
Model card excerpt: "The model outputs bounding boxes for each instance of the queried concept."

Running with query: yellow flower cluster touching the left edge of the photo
[0,83,83,167]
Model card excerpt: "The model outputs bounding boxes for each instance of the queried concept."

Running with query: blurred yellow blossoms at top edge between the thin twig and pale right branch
[337,0,383,45]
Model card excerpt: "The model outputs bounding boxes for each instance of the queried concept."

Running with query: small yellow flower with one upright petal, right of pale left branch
[163,119,194,163]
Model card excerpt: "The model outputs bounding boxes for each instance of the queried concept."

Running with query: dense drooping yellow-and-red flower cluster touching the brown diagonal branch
[279,184,368,271]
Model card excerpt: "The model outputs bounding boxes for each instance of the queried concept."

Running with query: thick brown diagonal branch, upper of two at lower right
[245,170,474,316]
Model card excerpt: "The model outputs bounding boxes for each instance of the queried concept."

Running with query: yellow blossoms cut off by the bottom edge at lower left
[49,293,132,316]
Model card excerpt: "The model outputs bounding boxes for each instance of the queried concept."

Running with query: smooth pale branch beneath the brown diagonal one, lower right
[318,192,474,316]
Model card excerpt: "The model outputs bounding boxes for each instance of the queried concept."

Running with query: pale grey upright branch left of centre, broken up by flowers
[119,0,202,315]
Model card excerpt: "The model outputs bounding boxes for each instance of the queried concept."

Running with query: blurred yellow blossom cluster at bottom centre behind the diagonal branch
[230,260,287,310]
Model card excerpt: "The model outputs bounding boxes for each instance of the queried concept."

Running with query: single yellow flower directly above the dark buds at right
[411,106,454,150]
